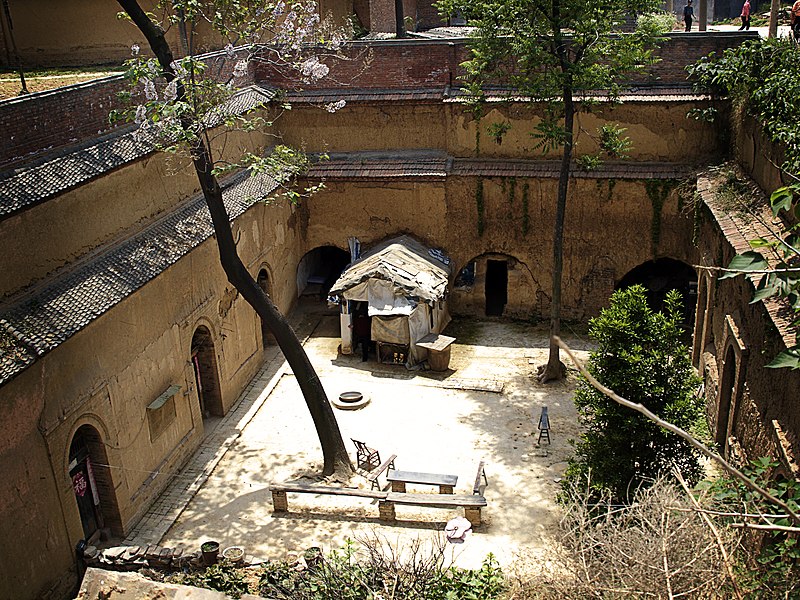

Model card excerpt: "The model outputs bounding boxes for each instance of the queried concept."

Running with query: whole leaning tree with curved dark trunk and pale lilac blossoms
[113,0,353,476]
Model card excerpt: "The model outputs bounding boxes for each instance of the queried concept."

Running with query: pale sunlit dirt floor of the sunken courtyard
[161,314,588,568]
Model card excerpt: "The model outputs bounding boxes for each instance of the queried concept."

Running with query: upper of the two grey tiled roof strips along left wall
[0,86,274,219]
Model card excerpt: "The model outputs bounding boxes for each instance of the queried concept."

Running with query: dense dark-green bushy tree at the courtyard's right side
[565,285,704,500]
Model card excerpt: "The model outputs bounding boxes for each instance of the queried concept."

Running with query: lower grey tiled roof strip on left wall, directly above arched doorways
[0,173,277,385]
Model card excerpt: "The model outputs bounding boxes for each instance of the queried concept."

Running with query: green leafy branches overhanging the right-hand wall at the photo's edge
[689,39,800,369]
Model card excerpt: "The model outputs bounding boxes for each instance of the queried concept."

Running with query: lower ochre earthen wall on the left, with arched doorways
[0,149,302,598]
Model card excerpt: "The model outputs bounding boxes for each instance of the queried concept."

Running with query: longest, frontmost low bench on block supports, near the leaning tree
[269,483,487,527]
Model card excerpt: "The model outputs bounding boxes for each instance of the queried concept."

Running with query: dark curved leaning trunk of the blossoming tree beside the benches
[117,0,353,478]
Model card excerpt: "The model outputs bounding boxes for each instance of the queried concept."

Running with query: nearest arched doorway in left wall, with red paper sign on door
[67,425,123,540]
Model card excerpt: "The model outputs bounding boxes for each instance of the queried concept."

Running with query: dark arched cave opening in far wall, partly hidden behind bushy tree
[615,258,697,331]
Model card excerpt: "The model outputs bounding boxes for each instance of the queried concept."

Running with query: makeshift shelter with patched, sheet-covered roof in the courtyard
[330,236,452,364]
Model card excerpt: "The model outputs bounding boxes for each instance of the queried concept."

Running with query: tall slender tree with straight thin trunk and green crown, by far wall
[437,0,661,381]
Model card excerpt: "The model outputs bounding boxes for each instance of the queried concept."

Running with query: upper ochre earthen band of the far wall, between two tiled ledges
[276,98,725,165]
